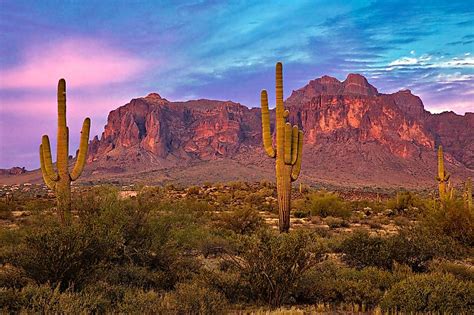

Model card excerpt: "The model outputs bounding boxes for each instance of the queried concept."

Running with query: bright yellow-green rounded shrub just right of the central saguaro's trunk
[303,191,352,219]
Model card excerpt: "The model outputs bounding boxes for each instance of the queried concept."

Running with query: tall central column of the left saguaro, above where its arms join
[56,79,69,178]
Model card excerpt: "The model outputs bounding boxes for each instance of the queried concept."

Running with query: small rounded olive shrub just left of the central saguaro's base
[222,207,263,234]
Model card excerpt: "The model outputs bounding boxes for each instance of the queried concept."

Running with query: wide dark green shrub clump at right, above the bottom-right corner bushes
[339,226,461,271]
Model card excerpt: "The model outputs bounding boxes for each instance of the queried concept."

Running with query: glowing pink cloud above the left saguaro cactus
[0,38,147,89]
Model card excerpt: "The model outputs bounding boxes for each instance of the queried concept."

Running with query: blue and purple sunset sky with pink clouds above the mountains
[0,0,474,169]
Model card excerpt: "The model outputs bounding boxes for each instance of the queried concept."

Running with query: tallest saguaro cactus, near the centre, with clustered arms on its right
[261,62,303,232]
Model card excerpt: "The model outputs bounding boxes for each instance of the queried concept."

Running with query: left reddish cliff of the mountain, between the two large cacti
[89,93,260,172]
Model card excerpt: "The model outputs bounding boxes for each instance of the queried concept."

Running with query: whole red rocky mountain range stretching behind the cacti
[88,74,474,186]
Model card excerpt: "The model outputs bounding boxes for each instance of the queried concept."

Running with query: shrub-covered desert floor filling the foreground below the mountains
[0,182,474,314]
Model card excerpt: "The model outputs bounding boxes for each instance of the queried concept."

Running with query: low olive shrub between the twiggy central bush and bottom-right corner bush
[297,261,398,308]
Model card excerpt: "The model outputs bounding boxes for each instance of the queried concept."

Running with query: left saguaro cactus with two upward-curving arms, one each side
[40,79,91,224]
